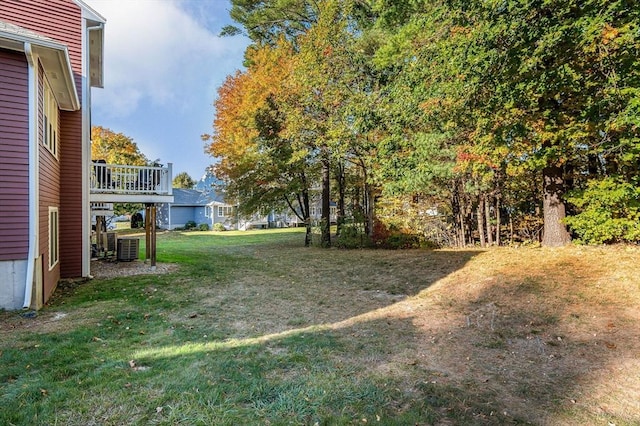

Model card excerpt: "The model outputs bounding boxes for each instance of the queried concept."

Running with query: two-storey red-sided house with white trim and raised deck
[0,0,172,309]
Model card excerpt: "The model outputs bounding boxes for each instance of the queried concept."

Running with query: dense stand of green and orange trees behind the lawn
[212,0,640,250]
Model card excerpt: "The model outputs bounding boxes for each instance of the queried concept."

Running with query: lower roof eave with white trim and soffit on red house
[0,21,80,111]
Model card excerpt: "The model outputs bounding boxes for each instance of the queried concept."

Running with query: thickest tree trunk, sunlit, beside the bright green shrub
[542,166,571,247]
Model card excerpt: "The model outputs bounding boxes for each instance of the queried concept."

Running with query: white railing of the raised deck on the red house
[90,162,172,195]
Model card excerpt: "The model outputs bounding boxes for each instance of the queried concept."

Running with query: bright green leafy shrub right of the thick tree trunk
[565,177,640,244]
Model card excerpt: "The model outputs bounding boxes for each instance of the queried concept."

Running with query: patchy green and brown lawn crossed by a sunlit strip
[0,230,640,425]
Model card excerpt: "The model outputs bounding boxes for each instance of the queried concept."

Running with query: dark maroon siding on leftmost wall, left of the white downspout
[0,50,29,260]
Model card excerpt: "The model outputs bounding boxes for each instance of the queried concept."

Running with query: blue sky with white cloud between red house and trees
[84,0,249,180]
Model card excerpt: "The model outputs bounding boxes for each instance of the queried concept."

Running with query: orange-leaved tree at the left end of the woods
[204,39,314,245]
